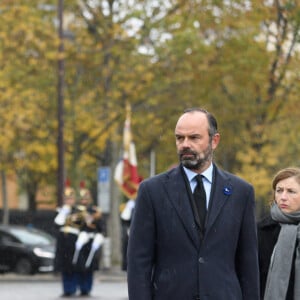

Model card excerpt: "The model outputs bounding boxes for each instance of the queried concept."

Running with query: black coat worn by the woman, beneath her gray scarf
[257,215,294,300]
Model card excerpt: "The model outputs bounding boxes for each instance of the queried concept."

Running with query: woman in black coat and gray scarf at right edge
[258,167,300,300]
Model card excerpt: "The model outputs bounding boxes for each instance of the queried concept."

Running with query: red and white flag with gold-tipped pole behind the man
[114,106,142,199]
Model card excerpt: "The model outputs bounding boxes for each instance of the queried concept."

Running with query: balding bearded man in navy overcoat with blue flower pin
[128,109,259,300]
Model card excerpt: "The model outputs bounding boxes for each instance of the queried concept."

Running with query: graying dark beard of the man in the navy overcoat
[178,144,213,170]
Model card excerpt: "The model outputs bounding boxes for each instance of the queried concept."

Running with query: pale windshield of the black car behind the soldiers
[10,228,53,245]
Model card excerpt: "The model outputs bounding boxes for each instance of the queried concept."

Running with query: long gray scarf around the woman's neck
[264,204,300,300]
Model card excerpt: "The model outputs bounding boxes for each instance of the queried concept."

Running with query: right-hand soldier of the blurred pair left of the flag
[73,188,104,295]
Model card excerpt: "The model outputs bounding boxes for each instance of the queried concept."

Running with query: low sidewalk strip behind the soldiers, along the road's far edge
[0,266,126,282]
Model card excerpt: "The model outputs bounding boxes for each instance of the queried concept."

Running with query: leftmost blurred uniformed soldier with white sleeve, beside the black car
[54,187,85,297]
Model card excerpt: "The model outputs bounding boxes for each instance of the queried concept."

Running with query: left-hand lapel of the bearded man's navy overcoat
[165,167,200,247]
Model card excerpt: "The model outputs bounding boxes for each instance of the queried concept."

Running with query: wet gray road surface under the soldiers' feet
[0,274,128,300]
